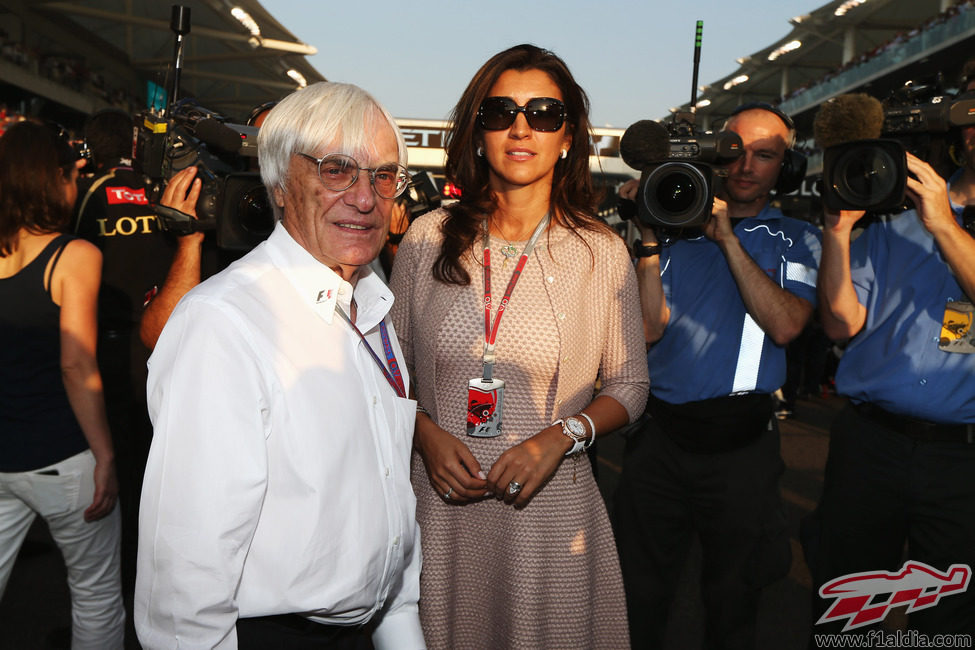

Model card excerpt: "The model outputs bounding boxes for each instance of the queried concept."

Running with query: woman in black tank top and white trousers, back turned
[0,122,125,650]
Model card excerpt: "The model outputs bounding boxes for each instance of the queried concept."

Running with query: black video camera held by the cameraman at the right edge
[822,86,975,212]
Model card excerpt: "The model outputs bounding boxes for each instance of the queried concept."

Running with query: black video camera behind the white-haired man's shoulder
[136,100,274,251]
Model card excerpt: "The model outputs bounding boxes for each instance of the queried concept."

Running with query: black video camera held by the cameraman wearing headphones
[624,113,743,230]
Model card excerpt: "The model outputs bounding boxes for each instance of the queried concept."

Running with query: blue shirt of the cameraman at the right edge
[836,177,975,423]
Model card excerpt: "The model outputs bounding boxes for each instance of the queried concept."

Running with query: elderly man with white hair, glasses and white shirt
[135,83,424,649]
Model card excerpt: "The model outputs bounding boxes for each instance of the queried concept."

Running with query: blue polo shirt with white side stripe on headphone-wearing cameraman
[647,204,821,404]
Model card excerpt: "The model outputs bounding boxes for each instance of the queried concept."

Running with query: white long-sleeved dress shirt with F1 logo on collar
[134,223,424,649]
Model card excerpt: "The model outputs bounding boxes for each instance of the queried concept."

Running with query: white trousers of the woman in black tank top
[0,451,125,650]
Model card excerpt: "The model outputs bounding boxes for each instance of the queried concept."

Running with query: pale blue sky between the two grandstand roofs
[262,0,824,128]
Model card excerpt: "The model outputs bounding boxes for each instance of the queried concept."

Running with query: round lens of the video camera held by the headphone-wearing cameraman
[642,162,711,228]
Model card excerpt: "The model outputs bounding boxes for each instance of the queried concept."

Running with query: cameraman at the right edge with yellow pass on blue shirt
[810,69,975,634]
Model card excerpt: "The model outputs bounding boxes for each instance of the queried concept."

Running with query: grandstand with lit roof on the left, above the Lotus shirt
[0,0,324,127]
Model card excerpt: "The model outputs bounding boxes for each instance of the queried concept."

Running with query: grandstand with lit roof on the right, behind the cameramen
[662,0,975,139]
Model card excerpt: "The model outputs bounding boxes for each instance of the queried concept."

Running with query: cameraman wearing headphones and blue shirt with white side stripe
[616,104,820,648]
